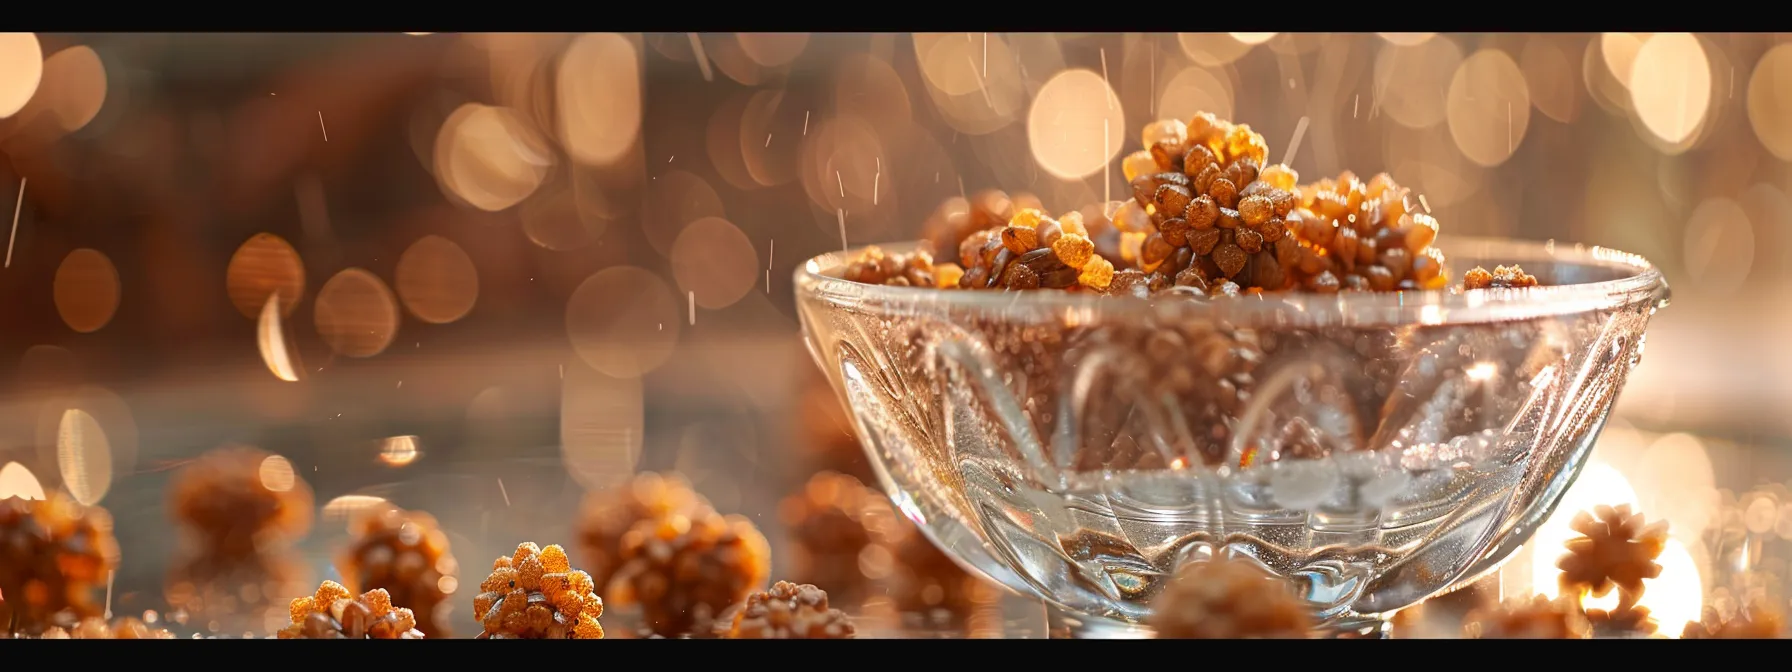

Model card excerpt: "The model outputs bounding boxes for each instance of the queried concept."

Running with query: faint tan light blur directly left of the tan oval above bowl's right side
[1373,38,1462,129]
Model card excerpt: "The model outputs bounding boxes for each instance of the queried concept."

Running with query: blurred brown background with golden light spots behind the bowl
[0,32,1792,633]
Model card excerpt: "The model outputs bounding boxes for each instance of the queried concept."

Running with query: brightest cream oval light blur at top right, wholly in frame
[1629,32,1711,143]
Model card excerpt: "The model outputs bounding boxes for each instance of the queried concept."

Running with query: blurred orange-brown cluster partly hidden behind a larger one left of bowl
[579,471,711,595]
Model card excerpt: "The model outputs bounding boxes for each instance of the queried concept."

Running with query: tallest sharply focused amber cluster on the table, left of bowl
[473,541,604,640]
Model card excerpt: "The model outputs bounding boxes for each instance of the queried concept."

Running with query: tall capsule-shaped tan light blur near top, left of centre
[559,32,642,165]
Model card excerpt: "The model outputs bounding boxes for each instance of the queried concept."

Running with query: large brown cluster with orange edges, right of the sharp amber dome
[606,511,771,636]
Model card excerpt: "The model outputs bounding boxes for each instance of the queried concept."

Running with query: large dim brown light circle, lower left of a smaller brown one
[566,265,686,378]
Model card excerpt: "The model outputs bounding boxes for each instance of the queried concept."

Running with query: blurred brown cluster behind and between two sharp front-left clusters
[336,507,461,638]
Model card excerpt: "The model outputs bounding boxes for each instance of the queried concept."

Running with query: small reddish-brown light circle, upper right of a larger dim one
[672,217,760,310]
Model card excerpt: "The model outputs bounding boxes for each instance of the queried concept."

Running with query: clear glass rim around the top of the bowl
[796,237,1670,326]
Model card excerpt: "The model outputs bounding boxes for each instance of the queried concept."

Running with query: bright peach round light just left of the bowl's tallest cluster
[1027,70,1125,179]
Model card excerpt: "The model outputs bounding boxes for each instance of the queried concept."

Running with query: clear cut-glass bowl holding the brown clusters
[796,237,1668,636]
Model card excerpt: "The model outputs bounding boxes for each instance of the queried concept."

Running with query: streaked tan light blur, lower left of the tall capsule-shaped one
[435,102,554,211]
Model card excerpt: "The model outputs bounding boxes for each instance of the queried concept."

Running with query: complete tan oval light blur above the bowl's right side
[1444,48,1530,167]
